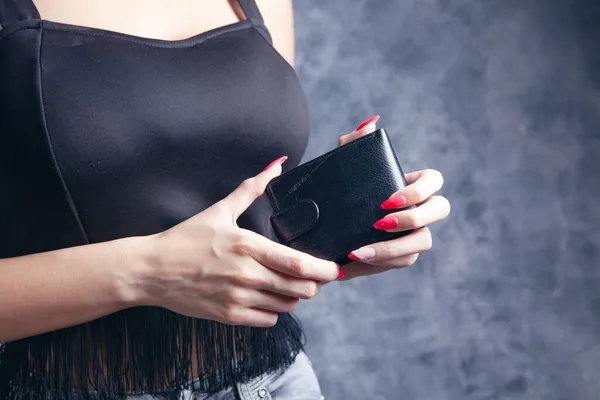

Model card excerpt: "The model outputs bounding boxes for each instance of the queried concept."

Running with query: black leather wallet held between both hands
[266,129,414,265]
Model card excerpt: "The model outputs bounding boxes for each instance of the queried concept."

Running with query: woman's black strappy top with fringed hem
[0,0,309,399]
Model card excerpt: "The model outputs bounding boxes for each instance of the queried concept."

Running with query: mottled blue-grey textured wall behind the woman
[294,0,600,400]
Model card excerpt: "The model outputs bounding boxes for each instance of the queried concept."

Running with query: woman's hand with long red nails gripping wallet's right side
[338,116,450,280]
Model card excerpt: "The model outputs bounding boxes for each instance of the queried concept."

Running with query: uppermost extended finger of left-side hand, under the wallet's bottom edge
[232,230,339,282]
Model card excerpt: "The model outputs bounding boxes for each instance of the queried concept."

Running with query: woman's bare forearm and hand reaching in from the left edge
[0,157,341,343]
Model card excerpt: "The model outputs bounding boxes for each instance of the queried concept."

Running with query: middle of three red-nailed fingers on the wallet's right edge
[373,196,450,232]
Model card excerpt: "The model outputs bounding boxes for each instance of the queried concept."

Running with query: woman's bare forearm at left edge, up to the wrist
[0,238,144,342]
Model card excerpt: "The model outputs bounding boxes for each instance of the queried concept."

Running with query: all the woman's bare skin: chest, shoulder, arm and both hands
[0,0,450,382]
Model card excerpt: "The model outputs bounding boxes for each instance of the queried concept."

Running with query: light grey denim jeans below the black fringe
[79,352,325,400]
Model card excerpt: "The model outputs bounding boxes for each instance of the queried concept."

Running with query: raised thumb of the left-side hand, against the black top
[221,156,288,221]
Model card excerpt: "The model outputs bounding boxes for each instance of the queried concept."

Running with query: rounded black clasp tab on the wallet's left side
[270,198,319,244]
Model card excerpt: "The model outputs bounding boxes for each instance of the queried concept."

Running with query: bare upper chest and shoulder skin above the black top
[34,0,294,66]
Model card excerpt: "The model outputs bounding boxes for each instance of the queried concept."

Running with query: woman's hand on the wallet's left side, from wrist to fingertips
[132,157,339,326]
